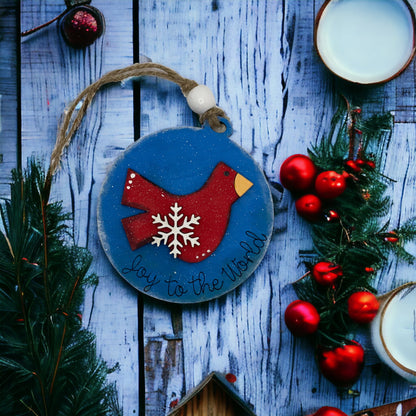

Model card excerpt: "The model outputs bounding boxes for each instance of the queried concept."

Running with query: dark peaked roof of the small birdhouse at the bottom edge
[167,372,256,416]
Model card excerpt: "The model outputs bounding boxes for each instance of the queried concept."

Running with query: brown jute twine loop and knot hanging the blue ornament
[45,62,228,200]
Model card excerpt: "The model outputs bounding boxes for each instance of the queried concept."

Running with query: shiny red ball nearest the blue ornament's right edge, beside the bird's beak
[280,154,318,192]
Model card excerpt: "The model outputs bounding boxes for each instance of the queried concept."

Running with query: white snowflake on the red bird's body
[152,202,201,259]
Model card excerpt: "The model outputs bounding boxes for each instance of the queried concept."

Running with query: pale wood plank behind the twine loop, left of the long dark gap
[21,0,139,414]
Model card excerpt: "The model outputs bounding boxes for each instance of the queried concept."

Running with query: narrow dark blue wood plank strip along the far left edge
[0,0,19,197]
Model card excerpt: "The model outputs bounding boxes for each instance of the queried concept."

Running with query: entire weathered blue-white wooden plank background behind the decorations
[0,0,416,416]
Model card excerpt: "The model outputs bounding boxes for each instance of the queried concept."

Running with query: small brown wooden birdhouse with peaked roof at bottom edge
[168,372,256,416]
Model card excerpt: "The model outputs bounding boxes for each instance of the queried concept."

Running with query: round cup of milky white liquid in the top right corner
[316,0,414,84]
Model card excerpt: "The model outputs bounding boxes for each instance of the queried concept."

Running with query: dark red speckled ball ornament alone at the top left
[60,6,105,48]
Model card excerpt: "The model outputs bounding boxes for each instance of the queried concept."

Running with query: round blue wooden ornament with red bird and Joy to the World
[98,121,273,303]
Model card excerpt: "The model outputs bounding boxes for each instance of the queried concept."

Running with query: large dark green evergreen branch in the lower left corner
[0,161,121,416]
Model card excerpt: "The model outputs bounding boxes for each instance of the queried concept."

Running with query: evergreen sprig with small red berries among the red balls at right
[294,103,416,348]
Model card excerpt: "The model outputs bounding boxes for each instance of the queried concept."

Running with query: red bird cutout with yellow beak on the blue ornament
[121,162,253,263]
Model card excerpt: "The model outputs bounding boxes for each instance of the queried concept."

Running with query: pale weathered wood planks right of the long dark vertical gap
[140,0,415,415]
